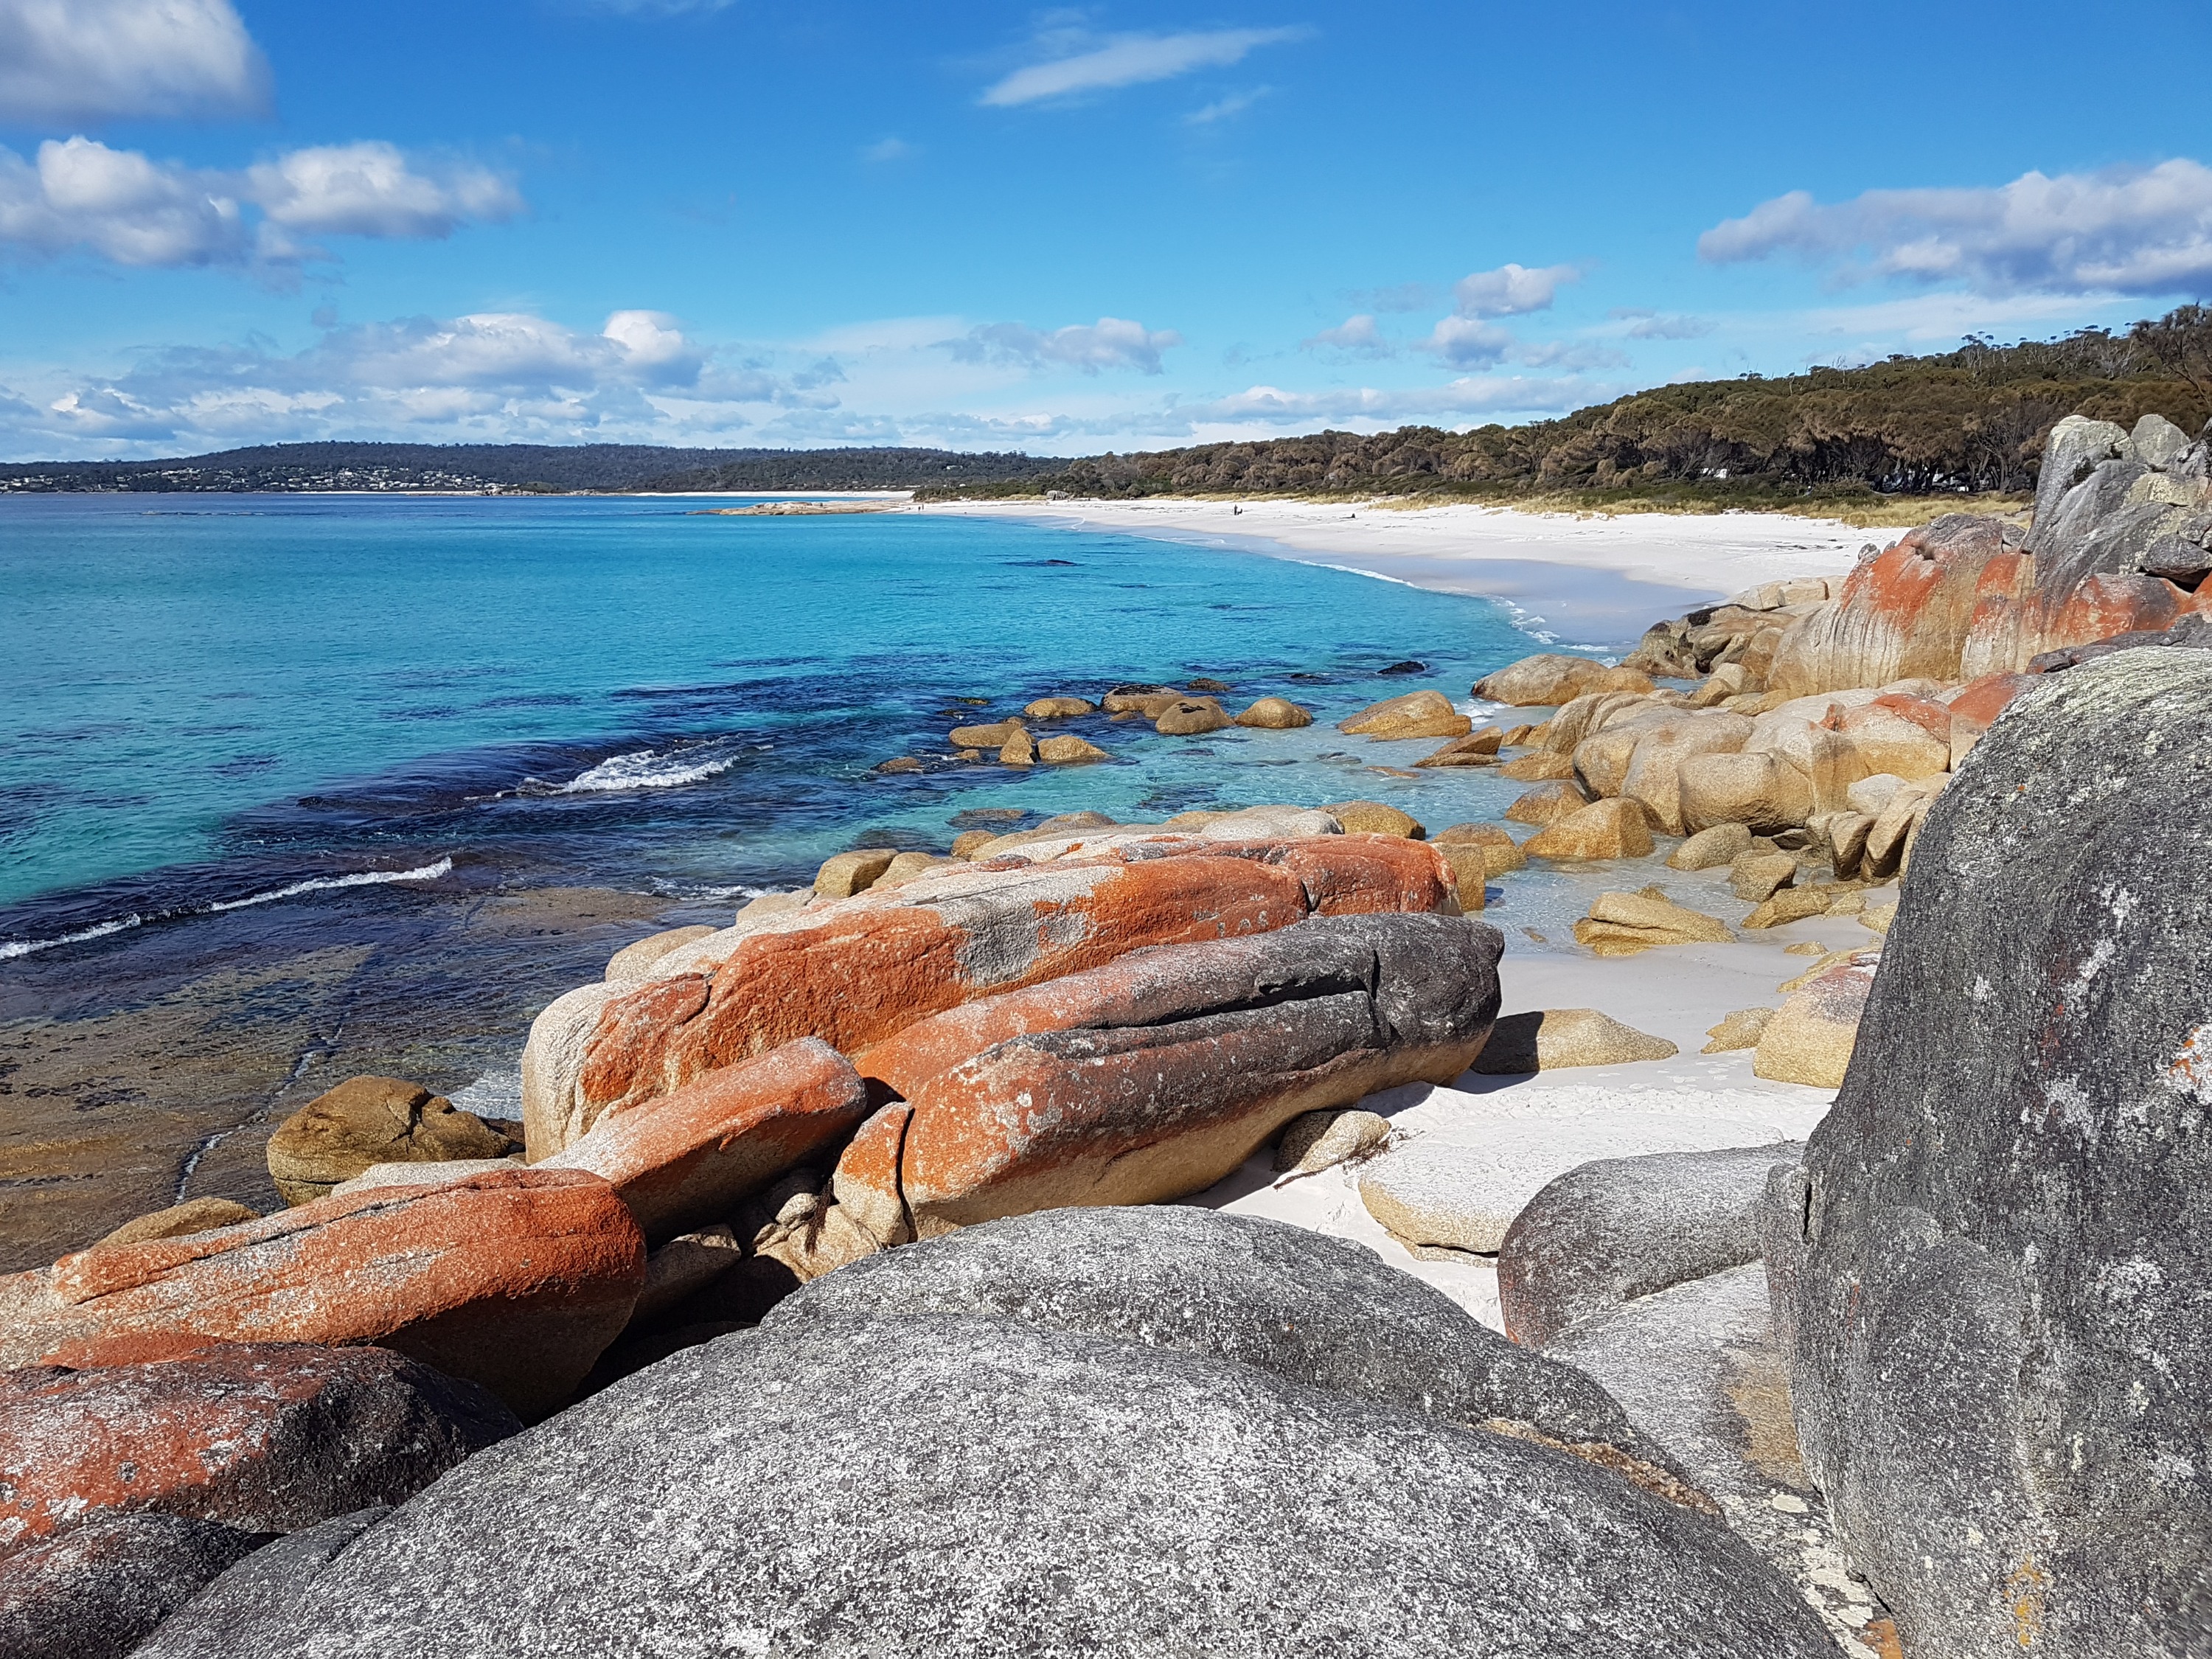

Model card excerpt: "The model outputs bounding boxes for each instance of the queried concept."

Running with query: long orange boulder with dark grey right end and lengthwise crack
[858,916,1502,1239]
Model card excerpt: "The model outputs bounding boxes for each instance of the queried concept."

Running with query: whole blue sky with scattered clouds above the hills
[0,0,2212,458]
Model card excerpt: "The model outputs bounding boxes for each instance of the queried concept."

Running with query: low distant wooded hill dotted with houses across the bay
[0,442,1057,493]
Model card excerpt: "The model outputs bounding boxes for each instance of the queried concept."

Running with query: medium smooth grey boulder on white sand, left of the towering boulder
[1498,1141,1805,1347]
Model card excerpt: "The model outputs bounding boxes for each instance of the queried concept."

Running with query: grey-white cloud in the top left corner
[0,0,268,126]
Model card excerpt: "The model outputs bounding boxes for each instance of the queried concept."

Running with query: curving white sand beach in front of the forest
[933,500,1902,646]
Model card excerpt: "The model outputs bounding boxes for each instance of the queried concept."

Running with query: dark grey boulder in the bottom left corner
[0,1515,268,1659]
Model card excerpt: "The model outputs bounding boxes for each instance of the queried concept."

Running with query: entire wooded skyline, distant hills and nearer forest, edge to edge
[0,305,2212,504]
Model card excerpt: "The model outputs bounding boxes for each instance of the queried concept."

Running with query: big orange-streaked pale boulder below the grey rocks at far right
[1767,513,2033,697]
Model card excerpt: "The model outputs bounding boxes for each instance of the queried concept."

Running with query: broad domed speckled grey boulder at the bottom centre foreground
[168,1316,1834,1659]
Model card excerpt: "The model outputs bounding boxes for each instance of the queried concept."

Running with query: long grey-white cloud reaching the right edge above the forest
[1697,159,2212,294]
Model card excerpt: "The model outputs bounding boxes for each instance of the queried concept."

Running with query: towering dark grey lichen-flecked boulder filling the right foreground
[1765,650,2212,1659]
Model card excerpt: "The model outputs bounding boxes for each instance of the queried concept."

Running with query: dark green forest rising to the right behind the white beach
[931,305,2212,500]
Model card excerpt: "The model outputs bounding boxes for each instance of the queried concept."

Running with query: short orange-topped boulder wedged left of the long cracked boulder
[538,1037,867,1243]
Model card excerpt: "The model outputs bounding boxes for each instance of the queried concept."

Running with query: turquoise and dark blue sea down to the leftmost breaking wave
[0,495,1593,967]
